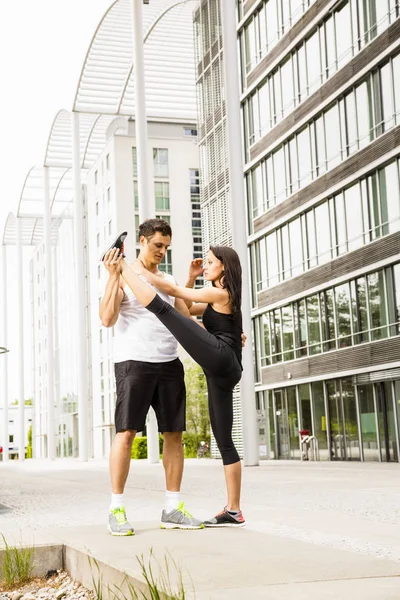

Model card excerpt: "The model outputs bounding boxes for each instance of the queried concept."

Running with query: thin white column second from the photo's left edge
[17,217,25,461]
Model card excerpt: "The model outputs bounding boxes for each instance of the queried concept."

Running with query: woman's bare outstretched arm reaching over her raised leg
[130,261,229,304]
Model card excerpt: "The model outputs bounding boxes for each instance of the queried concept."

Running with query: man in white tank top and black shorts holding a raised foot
[100,219,204,536]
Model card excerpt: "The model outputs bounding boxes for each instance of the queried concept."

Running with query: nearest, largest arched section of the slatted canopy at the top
[73,0,198,122]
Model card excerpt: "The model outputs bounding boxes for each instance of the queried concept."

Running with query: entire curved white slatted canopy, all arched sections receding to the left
[3,0,198,245]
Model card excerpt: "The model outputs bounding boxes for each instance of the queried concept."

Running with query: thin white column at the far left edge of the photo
[0,245,9,461]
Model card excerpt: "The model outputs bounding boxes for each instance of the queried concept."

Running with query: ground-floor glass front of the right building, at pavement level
[259,378,400,462]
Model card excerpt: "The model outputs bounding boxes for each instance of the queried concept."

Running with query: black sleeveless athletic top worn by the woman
[203,304,243,366]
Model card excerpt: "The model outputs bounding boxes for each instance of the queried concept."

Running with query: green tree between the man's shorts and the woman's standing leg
[183,359,210,456]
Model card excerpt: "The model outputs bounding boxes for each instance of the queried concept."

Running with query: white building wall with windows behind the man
[87,123,198,458]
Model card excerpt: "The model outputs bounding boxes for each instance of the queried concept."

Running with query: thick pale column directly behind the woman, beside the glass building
[221,0,259,466]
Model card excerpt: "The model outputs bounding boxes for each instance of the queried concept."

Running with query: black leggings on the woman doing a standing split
[146,294,242,465]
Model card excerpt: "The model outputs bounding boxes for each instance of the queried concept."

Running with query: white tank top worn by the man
[113,274,178,363]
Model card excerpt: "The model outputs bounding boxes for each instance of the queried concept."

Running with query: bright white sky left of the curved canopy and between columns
[0,0,113,398]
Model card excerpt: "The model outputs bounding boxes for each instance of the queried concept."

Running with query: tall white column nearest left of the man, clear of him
[72,111,89,461]
